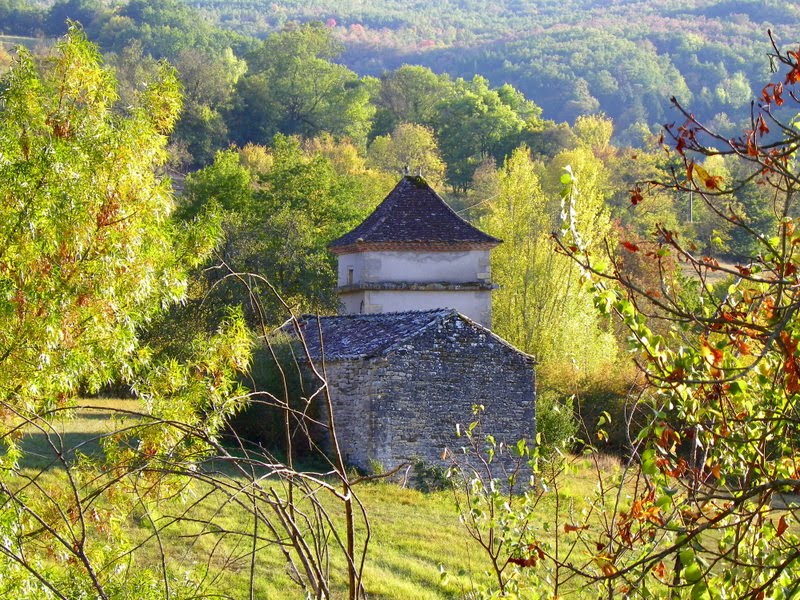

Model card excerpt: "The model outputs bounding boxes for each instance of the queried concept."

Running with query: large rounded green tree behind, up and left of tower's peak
[229,24,375,144]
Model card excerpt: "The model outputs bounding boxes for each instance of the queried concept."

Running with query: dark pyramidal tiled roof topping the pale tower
[328,175,500,252]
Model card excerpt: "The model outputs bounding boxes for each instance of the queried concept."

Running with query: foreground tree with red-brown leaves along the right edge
[548,34,800,599]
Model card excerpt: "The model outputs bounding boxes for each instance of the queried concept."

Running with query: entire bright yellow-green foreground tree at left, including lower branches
[0,27,249,599]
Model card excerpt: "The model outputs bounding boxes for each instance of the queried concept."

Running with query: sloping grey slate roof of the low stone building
[280,308,533,362]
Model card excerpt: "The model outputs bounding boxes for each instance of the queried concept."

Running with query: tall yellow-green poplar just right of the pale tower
[480,146,616,393]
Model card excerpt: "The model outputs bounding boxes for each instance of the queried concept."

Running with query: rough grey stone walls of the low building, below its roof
[316,317,536,469]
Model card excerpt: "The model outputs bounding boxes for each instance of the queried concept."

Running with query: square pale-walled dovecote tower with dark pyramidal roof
[329,175,500,328]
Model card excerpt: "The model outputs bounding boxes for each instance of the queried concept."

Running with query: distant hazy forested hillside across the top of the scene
[187,0,800,143]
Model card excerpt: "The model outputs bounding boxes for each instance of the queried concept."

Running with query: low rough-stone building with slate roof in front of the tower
[290,309,535,469]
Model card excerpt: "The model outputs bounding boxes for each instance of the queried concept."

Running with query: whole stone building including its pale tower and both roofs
[283,176,535,469]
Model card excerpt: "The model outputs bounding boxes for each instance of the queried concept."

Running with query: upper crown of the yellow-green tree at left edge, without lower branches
[0,24,191,411]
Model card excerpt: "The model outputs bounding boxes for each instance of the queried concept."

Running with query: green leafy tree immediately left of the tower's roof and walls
[183,136,383,327]
